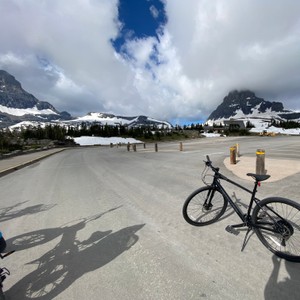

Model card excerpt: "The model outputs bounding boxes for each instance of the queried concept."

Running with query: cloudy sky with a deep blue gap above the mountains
[0,0,300,123]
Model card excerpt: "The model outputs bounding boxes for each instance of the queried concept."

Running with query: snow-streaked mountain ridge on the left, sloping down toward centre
[0,70,172,129]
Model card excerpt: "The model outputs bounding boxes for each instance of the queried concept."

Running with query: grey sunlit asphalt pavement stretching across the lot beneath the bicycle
[0,137,300,300]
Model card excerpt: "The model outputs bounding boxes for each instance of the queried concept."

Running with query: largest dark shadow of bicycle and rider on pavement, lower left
[5,207,145,300]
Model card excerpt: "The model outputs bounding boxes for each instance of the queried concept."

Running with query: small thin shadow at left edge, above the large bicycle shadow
[0,201,56,222]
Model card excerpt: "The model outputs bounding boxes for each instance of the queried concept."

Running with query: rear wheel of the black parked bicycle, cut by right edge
[252,197,300,262]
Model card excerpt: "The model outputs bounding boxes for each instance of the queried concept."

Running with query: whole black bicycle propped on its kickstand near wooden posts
[182,155,300,262]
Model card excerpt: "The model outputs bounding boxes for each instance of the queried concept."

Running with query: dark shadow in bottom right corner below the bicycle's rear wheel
[265,255,300,300]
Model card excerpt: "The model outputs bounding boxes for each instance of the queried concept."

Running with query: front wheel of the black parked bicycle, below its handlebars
[182,186,228,226]
